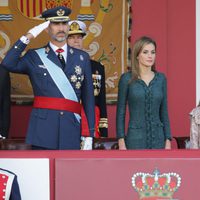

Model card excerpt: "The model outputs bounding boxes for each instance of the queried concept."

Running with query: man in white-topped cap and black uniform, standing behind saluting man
[67,20,108,138]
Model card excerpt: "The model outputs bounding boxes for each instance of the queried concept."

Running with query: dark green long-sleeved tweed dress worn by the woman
[116,72,171,149]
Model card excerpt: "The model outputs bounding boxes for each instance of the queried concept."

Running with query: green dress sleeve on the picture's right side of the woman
[160,76,172,140]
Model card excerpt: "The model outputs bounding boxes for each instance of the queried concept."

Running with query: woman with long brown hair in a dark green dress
[116,36,171,150]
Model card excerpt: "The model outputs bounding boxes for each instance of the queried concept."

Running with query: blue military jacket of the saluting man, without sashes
[2,40,95,149]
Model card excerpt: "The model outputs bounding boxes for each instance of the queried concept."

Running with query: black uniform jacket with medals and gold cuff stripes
[91,60,108,137]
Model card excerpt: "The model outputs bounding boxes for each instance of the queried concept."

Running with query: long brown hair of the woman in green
[131,36,157,80]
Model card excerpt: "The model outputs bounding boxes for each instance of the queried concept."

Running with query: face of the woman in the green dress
[137,43,156,67]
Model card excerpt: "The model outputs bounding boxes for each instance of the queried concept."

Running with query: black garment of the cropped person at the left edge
[0,65,10,138]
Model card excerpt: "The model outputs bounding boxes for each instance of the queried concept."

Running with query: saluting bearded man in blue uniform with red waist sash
[2,6,95,149]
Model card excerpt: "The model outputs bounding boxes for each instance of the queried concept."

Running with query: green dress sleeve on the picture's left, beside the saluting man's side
[116,73,130,138]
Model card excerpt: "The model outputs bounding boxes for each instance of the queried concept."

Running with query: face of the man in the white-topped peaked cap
[67,34,83,49]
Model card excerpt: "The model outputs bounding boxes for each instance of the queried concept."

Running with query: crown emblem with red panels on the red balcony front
[132,169,181,200]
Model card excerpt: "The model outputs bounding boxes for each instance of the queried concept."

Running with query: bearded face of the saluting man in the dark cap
[47,22,69,42]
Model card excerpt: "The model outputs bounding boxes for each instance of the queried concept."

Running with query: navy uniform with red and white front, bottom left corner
[0,168,21,200]
